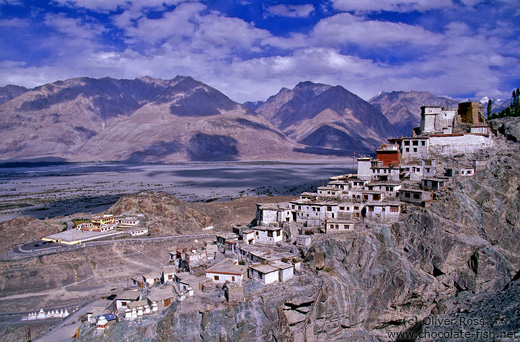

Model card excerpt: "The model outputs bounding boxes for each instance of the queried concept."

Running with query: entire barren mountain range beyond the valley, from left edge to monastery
[0,76,457,162]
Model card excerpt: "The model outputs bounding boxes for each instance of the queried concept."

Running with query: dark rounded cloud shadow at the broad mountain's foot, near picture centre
[186,133,239,161]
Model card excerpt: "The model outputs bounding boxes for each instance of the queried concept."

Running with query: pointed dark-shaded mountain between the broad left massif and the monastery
[256,82,395,154]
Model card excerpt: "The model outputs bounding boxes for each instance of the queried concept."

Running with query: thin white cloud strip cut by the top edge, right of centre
[332,0,452,12]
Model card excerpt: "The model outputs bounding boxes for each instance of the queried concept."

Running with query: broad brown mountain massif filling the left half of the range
[0,76,296,162]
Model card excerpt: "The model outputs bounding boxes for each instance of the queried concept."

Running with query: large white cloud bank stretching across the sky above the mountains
[0,0,520,102]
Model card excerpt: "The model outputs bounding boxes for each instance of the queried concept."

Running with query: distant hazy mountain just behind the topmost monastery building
[368,90,458,136]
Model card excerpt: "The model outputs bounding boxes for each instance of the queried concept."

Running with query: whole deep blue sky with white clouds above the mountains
[0,0,520,102]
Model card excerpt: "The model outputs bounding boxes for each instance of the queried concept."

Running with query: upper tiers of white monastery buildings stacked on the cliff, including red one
[256,102,493,234]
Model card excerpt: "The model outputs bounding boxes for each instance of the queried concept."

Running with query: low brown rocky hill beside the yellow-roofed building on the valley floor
[106,192,213,235]
